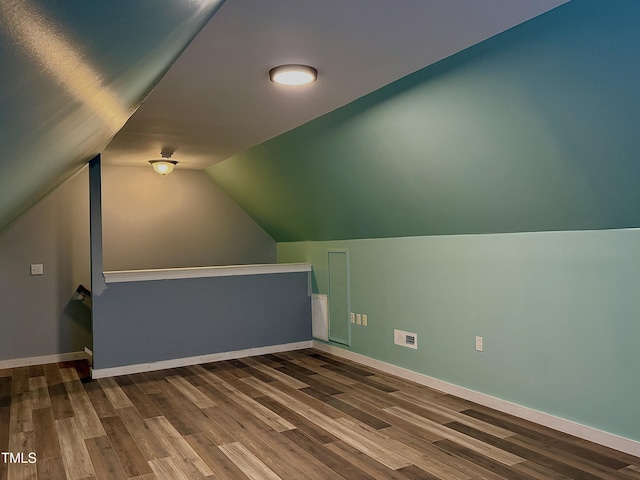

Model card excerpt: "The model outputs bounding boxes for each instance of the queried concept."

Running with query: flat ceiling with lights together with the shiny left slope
[0,0,566,229]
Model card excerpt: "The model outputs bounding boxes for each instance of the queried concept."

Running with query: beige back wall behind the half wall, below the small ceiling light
[102,165,276,271]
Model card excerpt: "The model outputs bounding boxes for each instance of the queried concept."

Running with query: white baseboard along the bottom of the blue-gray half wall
[91,340,313,379]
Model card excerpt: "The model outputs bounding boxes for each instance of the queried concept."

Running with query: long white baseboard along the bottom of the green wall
[313,341,640,457]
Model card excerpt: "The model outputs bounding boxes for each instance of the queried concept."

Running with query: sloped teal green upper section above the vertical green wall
[208,0,640,241]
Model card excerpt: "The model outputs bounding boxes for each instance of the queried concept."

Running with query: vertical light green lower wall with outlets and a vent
[278,230,640,440]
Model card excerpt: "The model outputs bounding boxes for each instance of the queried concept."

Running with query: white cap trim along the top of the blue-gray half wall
[103,263,311,283]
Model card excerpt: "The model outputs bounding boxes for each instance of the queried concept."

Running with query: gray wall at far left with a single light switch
[0,167,91,360]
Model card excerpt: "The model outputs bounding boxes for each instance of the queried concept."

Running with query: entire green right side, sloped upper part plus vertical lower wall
[207,0,640,440]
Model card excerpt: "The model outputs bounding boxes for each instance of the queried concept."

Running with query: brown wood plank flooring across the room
[0,350,640,480]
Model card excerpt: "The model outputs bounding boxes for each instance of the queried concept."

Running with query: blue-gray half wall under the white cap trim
[93,272,311,369]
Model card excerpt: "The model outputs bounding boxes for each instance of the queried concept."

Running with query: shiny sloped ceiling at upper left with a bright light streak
[0,0,222,229]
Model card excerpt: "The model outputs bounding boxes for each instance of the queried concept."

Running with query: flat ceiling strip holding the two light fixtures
[103,0,567,169]
